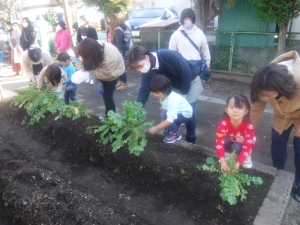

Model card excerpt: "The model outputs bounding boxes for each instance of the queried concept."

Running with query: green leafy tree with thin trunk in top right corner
[250,0,300,55]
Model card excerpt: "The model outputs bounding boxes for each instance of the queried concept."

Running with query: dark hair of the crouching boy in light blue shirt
[150,74,172,95]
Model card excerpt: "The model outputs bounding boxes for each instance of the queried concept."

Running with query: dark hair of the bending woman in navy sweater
[128,46,155,68]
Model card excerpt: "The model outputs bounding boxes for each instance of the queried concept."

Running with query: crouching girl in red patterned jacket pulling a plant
[216,95,256,172]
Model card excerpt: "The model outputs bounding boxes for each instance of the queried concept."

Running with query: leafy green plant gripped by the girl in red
[196,152,263,205]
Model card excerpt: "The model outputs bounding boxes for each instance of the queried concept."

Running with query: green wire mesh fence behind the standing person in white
[133,30,300,76]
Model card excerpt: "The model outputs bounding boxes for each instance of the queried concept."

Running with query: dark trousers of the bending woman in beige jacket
[102,79,118,115]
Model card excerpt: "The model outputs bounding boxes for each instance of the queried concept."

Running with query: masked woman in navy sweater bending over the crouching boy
[128,46,202,144]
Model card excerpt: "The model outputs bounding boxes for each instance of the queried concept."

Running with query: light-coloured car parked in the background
[126,8,178,38]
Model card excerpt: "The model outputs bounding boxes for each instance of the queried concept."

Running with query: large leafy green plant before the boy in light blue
[87,100,153,156]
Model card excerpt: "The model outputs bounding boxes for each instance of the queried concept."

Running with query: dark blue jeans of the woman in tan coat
[271,125,300,185]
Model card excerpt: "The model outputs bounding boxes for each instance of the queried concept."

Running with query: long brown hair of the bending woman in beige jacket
[78,38,104,71]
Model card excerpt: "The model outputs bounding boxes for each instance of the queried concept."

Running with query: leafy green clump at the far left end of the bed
[11,83,90,125]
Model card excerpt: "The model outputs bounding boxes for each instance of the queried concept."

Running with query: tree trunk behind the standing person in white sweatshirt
[195,0,210,33]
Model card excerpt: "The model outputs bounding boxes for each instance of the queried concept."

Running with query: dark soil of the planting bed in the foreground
[0,103,274,225]
